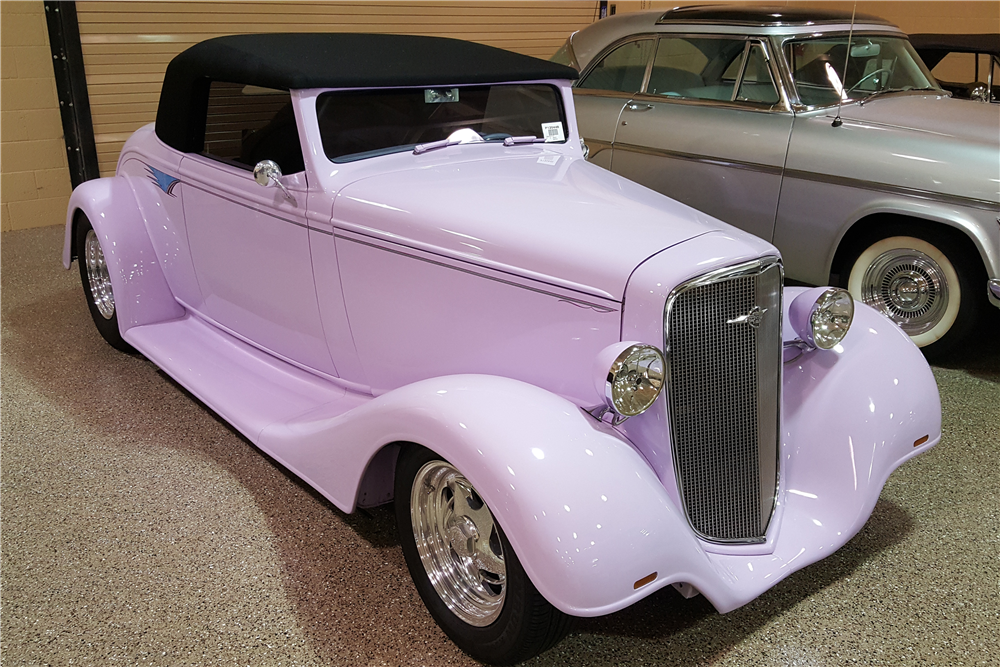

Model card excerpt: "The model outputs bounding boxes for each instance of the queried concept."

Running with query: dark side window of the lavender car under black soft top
[202,81,305,174]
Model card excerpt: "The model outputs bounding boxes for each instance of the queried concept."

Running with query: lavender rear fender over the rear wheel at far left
[63,176,184,334]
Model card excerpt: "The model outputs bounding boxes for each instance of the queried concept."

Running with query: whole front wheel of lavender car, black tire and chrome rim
[395,445,570,665]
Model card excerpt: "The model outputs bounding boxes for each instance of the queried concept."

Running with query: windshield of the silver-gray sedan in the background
[785,34,938,106]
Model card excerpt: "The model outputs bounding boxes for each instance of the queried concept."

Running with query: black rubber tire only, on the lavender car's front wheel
[395,445,572,665]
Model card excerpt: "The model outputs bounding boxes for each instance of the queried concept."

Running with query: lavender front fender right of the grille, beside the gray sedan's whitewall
[782,287,941,535]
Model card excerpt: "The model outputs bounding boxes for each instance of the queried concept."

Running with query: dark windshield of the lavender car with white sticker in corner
[316,84,568,162]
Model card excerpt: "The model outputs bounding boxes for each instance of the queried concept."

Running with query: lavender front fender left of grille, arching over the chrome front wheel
[259,375,717,616]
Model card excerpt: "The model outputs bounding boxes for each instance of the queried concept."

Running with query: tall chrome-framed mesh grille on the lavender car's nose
[664,258,782,542]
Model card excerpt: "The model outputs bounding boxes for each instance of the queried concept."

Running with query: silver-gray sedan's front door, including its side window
[592,35,794,240]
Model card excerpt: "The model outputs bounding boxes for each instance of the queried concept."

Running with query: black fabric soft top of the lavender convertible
[156,33,579,152]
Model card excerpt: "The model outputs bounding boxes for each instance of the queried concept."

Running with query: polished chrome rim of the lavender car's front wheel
[410,461,507,627]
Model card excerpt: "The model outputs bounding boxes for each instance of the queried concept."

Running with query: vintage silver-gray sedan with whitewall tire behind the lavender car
[553,6,1000,353]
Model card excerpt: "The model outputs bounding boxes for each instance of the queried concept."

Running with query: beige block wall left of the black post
[0,0,70,231]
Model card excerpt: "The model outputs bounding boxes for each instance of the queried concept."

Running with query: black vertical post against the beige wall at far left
[44,0,101,188]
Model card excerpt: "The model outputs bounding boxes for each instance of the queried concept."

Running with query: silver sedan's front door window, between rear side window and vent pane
[647,37,746,102]
